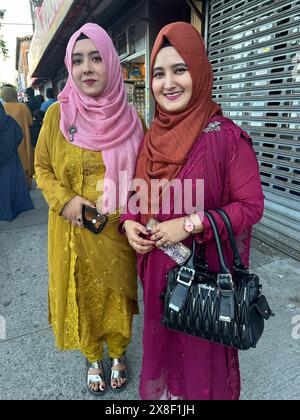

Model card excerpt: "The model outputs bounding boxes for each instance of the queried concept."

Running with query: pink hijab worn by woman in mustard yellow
[58,23,144,212]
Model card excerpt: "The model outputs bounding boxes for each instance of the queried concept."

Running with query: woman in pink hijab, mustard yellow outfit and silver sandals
[35,24,143,396]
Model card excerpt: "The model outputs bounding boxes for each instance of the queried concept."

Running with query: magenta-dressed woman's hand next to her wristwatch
[150,217,190,247]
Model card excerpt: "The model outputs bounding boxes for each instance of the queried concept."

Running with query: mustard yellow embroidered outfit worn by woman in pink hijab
[35,103,138,361]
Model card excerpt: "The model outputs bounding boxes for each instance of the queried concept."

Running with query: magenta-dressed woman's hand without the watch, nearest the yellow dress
[123,220,155,255]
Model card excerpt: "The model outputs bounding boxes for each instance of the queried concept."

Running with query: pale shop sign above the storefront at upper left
[29,0,74,75]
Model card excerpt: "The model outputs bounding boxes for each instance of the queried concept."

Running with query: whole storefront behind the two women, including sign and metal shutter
[30,0,300,259]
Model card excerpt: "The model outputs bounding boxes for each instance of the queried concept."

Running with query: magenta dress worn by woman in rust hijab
[122,116,263,400]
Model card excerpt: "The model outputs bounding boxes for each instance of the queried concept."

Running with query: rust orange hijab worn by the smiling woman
[135,22,221,222]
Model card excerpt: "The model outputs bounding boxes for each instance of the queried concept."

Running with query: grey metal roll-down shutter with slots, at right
[207,0,300,259]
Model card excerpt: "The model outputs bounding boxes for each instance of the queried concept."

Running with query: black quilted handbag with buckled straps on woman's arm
[162,209,274,350]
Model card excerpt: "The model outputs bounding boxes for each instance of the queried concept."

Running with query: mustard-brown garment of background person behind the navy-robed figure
[4,102,34,188]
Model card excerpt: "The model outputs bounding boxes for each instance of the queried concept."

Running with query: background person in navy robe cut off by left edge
[0,104,33,221]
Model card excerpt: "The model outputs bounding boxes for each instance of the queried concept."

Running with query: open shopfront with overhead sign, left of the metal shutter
[30,0,204,115]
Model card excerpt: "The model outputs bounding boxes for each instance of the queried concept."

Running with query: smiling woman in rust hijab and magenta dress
[122,22,263,400]
